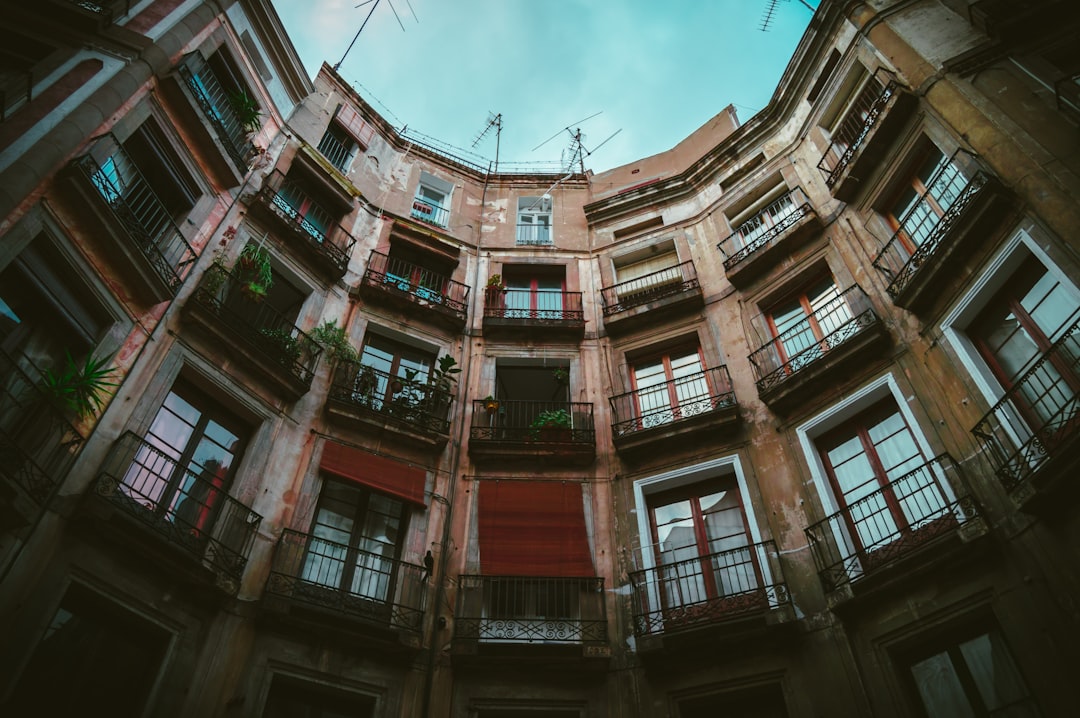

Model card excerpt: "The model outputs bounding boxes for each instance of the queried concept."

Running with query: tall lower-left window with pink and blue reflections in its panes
[119,381,248,531]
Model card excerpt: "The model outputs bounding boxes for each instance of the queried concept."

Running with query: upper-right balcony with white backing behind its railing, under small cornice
[716,187,821,289]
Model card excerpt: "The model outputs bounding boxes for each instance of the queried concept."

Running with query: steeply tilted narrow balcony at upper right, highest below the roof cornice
[818,68,918,202]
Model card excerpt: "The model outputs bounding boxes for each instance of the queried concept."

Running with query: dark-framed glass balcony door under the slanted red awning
[301,480,406,604]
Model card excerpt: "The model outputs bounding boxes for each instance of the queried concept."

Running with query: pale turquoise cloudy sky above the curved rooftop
[267,0,818,172]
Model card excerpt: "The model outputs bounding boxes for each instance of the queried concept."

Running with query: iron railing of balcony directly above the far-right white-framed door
[873,150,991,299]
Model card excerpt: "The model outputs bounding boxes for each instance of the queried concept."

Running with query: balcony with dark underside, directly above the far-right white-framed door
[874,156,1013,313]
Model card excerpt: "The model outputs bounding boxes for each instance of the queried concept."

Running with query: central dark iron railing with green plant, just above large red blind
[469,399,596,444]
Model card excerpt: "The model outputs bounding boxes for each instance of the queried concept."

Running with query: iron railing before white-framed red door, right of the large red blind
[630,541,791,636]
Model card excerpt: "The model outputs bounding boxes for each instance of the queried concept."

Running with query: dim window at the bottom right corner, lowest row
[906,628,1042,718]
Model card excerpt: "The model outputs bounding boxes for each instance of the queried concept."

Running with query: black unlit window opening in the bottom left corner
[0,584,170,718]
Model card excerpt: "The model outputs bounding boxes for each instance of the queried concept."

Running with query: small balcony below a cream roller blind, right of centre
[600,260,705,334]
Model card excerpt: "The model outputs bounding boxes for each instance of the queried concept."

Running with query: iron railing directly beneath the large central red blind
[454,575,607,645]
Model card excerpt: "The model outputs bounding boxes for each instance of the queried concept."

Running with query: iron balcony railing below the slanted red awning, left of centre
[266,529,428,633]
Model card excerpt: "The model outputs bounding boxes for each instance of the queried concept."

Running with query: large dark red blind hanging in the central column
[480,480,596,578]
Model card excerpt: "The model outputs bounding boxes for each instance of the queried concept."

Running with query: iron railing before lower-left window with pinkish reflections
[90,432,262,583]
